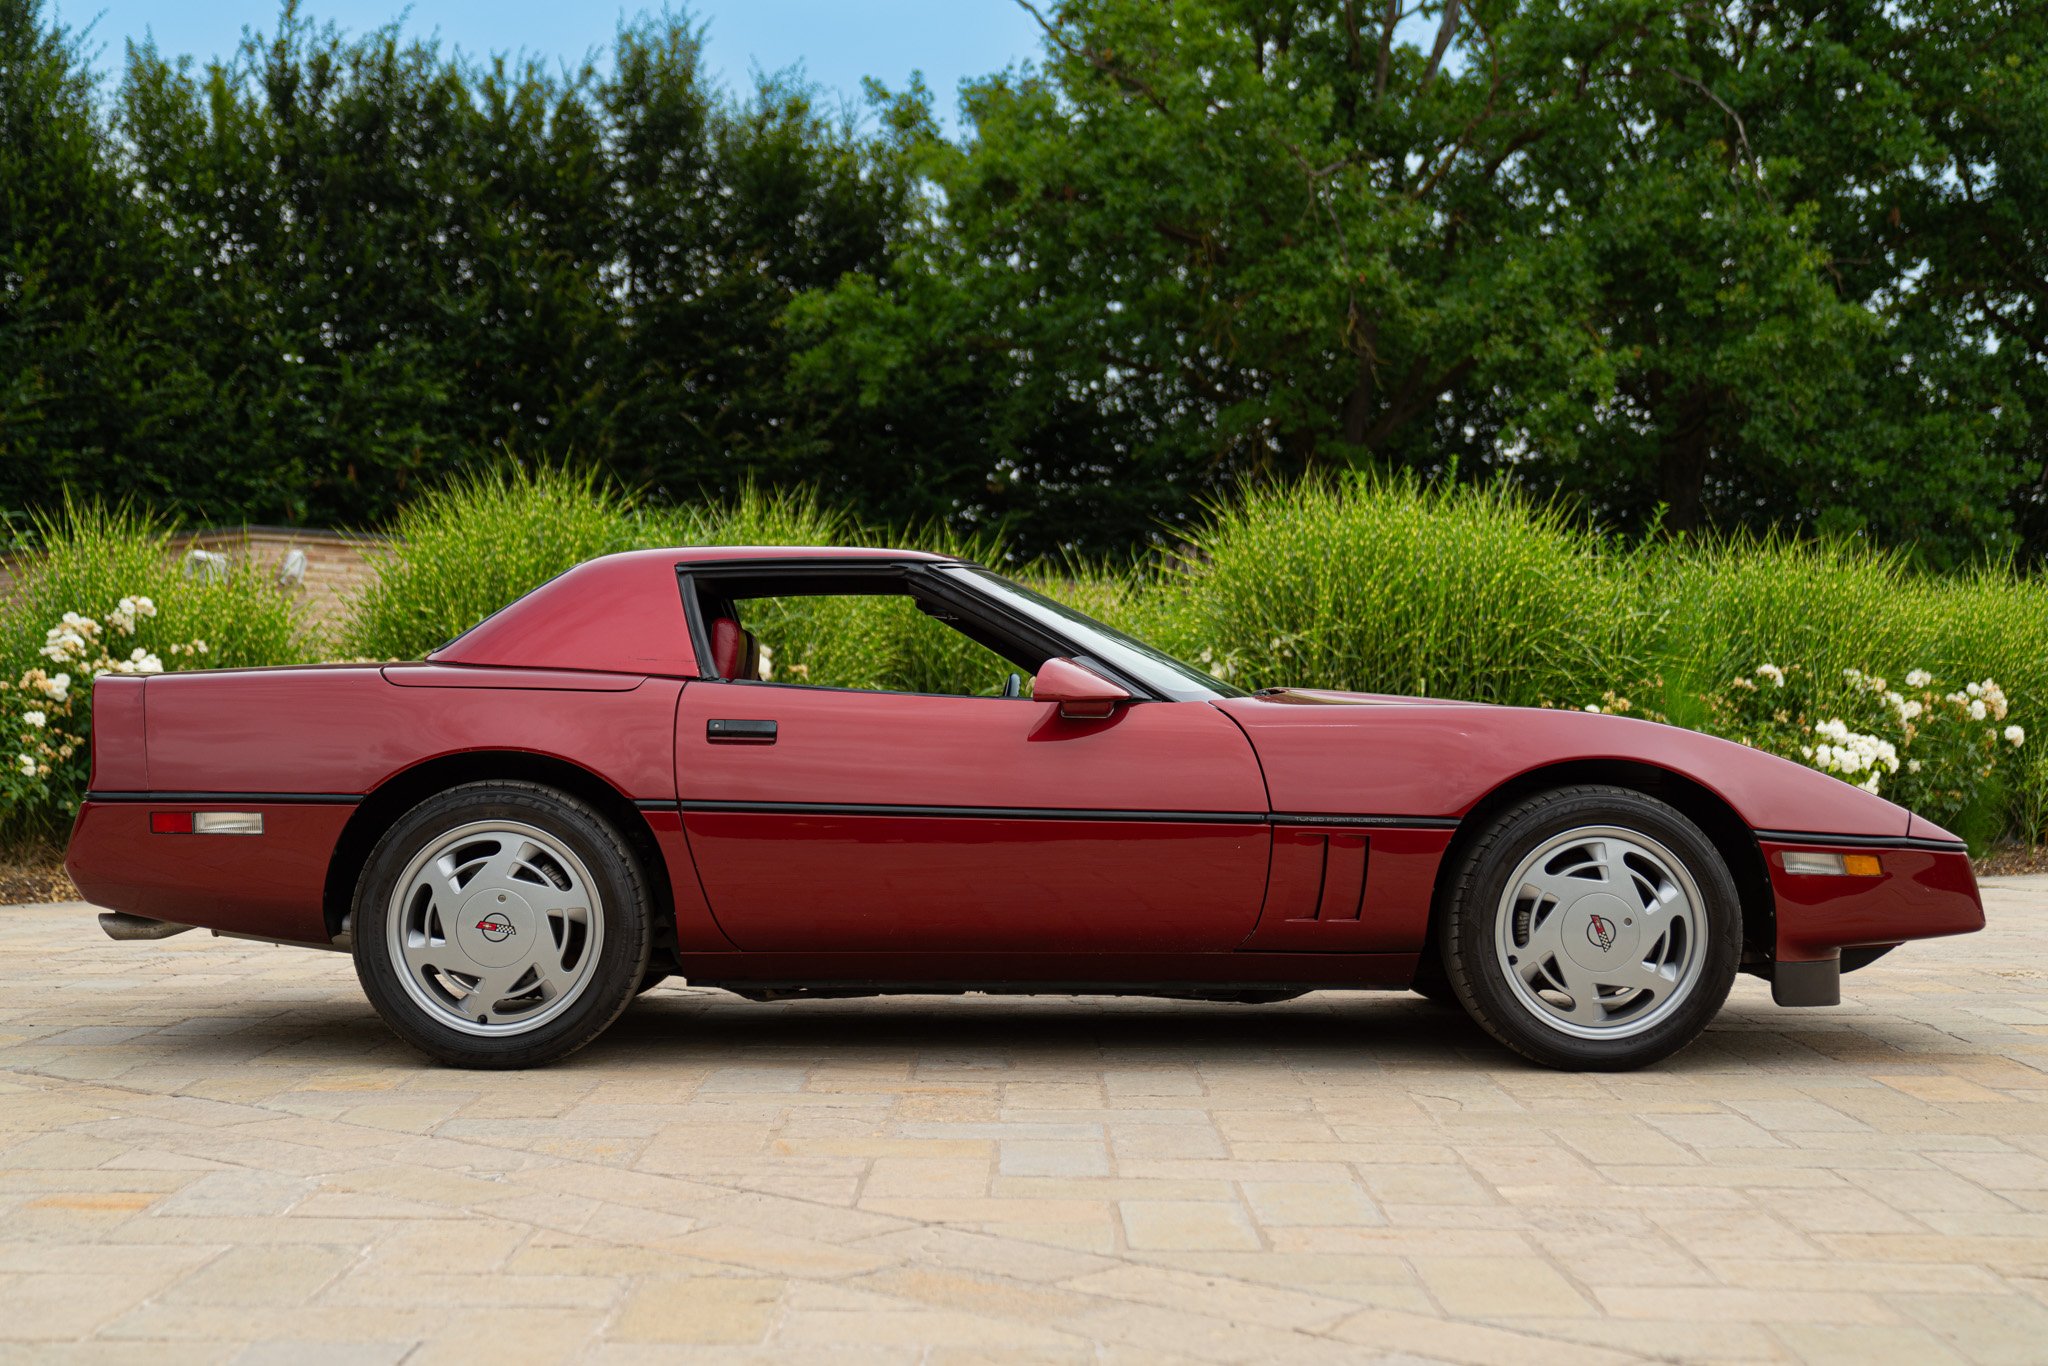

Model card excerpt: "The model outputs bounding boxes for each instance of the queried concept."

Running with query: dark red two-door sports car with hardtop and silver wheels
[68,549,1985,1069]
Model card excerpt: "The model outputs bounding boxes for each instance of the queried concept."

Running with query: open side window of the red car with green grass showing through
[729,592,1032,696]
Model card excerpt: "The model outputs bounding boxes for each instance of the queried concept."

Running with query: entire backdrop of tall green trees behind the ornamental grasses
[12,0,2048,565]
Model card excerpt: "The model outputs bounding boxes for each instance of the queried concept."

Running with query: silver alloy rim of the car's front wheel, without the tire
[1493,825,1708,1038]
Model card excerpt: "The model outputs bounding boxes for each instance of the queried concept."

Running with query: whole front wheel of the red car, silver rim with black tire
[1442,786,1743,1071]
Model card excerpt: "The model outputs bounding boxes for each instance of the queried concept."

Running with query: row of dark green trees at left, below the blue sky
[12,0,911,524]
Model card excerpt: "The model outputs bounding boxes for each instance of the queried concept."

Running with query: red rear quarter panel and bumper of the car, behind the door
[66,666,682,942]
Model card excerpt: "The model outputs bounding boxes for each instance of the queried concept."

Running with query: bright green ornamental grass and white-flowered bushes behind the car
[0,469,2048,844]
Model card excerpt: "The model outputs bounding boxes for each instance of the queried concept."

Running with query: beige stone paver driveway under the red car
[0,879,2048,1364]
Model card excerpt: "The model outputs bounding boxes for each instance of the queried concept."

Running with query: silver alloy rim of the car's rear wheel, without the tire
[385,821,604,1036]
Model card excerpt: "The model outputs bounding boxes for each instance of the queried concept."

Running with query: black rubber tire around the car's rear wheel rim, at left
[352,780,653,1069]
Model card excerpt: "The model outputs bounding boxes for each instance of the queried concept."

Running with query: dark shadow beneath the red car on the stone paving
[79,987,1958,1073]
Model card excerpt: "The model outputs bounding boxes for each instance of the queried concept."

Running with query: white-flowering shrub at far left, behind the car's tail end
[0,594,211,817]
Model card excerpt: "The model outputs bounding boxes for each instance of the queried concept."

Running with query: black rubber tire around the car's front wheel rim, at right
[1441,784,1743,1071]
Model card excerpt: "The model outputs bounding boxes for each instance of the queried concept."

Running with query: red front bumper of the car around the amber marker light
[1757,834,1985,963]
